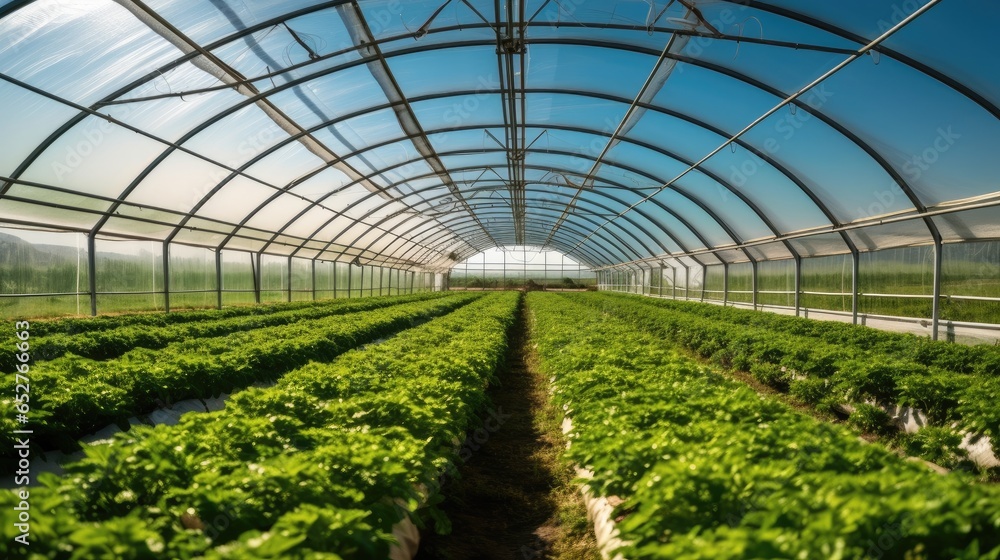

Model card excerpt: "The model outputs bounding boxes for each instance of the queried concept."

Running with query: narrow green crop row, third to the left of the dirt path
[0,292,443,372]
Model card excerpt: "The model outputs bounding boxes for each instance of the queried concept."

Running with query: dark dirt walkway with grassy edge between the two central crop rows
[416,298,599,560]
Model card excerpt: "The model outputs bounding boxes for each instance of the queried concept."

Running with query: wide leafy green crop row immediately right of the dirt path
[528,293,1000,559]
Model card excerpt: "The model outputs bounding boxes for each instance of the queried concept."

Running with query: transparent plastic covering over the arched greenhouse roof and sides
[0,0,1000,276]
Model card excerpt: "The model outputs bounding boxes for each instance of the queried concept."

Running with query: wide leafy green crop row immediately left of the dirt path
[0,294,518,559]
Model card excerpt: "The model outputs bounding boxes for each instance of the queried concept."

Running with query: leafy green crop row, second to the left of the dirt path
[0,294,480,464]
